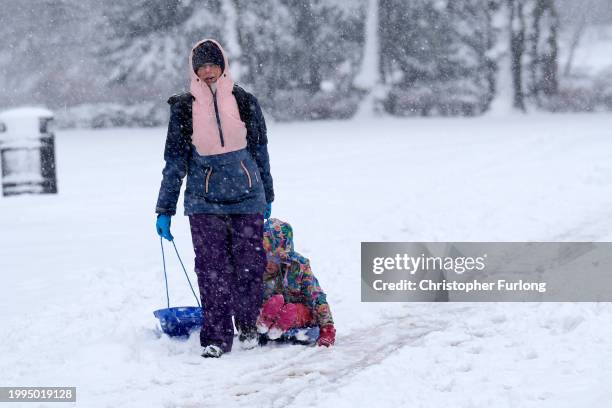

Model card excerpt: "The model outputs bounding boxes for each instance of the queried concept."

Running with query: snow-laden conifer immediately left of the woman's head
[98,0,223,101]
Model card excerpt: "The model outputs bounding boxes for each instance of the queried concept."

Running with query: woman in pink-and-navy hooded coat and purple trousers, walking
[156,40,274,357]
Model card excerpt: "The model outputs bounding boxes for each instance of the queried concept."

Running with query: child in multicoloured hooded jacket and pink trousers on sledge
[257,218,336,347]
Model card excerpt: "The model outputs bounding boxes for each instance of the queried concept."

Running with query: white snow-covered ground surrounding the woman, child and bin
[0,114,612,408]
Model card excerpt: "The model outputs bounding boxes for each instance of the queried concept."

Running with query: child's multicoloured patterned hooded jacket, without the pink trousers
[263,218,334,327]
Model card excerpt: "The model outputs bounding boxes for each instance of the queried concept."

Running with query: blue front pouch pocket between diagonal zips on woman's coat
[202,161,255,204]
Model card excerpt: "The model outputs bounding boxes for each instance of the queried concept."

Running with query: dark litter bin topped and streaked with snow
[0,108,57,196]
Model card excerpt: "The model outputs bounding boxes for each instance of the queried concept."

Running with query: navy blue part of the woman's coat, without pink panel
[155,86,274,215]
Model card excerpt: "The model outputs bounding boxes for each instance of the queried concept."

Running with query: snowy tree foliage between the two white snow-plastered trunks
[380,0,496,115]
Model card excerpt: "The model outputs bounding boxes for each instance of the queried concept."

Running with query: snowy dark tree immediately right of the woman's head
[236,0,363,120]
